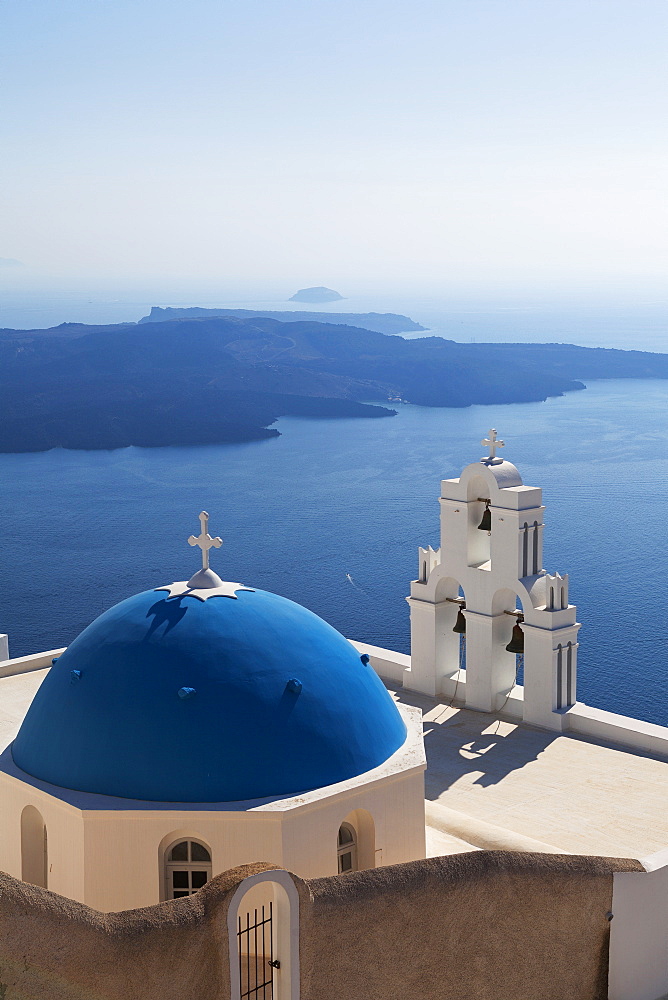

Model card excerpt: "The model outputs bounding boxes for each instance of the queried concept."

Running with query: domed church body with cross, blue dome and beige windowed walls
[0,512,426,911]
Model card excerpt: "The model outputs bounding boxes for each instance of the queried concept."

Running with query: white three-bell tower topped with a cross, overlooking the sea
[404,430,580,730]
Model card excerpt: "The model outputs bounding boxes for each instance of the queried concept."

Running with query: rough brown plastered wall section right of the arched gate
[301,851,642,1000]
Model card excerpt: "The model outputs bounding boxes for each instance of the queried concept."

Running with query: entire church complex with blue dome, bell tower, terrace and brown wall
[0,430,668,1000]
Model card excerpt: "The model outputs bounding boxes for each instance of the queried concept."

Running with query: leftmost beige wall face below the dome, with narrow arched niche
[0,772,84,899]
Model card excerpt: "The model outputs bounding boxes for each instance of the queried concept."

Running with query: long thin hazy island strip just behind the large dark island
[139,306,426,333]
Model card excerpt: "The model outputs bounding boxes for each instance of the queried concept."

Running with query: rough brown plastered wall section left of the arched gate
[0,864,276,1000]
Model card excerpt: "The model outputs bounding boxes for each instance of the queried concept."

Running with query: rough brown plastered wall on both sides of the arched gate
[0,851,642,1000]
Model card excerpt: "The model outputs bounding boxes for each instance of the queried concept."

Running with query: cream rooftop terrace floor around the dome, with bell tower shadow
[0,647,668,859]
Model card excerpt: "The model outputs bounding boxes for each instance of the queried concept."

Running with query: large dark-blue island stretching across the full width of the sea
[0,310,668,452]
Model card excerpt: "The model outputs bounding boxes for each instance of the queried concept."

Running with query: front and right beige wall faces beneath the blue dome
[79,769,425,912]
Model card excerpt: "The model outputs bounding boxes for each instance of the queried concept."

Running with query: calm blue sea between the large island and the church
[0,380,668,724]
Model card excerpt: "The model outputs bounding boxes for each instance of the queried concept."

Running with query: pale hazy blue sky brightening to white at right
[0,0,668,294]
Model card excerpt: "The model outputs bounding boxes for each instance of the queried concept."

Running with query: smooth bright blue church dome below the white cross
[12,590,406,802]
